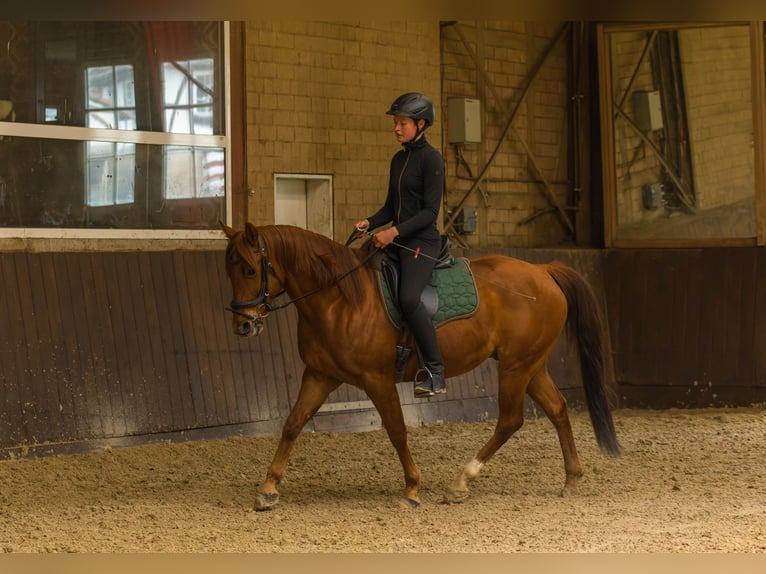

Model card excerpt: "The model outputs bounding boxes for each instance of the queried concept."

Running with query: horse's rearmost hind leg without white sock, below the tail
[527,367,582,496]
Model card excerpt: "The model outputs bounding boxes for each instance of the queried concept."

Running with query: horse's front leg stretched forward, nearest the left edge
[255,367,340,510]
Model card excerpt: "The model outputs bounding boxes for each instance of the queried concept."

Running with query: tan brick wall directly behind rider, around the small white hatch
[246,21,441,240]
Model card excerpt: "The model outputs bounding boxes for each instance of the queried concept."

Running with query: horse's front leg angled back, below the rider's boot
[365,376,420,508]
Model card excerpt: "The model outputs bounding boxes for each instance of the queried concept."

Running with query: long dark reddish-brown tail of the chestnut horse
[548,262,621,456]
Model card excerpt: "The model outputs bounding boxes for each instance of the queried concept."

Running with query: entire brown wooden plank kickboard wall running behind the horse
[18,248,766,454]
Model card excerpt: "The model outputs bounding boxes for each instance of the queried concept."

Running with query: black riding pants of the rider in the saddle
[399,236,444,374]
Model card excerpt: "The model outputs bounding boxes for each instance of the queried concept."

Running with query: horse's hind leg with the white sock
[444,364,529,503]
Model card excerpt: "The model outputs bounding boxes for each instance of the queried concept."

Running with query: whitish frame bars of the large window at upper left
[0,21,233,244]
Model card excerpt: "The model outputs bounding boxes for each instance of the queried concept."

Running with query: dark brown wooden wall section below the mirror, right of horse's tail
[605,248,766,408]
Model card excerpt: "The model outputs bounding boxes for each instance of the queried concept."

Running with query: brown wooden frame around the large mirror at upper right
[596,21,766,248]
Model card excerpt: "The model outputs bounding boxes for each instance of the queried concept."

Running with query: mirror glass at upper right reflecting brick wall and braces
[601,24,762,241]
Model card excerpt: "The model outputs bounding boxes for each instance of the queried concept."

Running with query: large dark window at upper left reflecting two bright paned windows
[0,21,228,229]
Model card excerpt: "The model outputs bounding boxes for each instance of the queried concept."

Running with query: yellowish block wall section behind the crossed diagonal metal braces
[442,21,569,248]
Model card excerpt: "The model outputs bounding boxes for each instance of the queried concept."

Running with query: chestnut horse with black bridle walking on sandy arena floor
[222,223,620,510]
